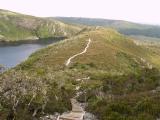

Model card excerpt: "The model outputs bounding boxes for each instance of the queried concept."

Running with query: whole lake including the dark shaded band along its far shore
[0,37,65,69]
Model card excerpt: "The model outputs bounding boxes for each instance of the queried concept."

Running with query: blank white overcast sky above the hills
[0,0,160,25]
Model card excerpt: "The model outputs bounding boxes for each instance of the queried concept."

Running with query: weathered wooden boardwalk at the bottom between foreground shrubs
[57,98,85,120]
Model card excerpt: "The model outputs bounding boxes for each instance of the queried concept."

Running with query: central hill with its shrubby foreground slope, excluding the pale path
[0,29,160,120]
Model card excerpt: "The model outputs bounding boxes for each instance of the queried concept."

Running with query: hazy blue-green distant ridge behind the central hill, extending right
[56,17,160,38]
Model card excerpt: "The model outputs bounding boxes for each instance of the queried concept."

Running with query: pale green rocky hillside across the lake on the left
[0,10,81,41]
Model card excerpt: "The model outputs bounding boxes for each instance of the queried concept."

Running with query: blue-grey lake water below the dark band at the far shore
[0,41,57,68]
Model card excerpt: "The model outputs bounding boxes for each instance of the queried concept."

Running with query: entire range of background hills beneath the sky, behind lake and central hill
[0,9,160,41]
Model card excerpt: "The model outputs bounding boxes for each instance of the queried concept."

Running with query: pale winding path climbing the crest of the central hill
[65,38,91,66]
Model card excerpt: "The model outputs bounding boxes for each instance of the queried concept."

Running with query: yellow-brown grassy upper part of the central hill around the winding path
[14,28,158,73]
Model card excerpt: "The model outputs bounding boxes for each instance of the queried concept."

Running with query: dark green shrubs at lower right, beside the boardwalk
[86,68,160,120]
